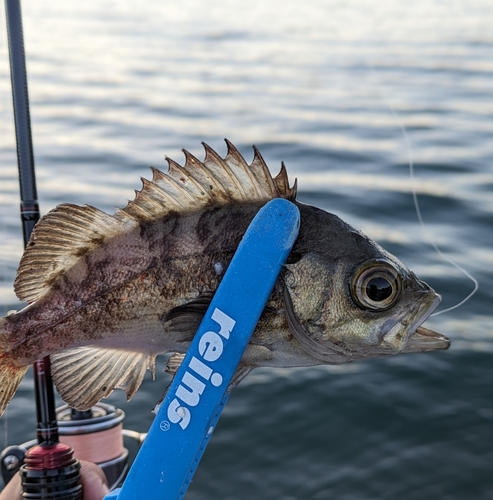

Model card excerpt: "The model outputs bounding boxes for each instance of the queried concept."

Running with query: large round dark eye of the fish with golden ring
[351,260,402,311]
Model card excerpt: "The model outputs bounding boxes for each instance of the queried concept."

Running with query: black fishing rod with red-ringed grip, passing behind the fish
[5,0,82,500]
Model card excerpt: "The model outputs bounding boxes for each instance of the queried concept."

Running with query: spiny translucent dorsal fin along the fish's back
[14,140,296,302]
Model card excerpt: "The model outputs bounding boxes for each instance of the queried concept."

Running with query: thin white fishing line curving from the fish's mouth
[366,61,479,316]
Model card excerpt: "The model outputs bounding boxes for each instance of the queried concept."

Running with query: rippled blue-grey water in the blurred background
[0,0,493,500]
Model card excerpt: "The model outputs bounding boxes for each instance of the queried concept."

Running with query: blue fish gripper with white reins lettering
[105,198,300,500]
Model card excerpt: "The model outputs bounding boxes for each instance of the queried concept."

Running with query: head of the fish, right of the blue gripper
[283,205,450,364]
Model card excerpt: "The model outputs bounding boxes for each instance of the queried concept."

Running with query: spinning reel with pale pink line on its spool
[0,403,146,490]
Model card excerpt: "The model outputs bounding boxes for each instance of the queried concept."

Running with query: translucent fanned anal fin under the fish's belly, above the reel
[51,347,155,410]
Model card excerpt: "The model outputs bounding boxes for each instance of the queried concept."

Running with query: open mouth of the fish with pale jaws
[383,294,450,353]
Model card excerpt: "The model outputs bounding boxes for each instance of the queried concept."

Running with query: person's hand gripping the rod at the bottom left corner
[0,460,109,500]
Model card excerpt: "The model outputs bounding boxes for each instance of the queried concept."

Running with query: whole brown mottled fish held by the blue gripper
[0,140,450,415]
